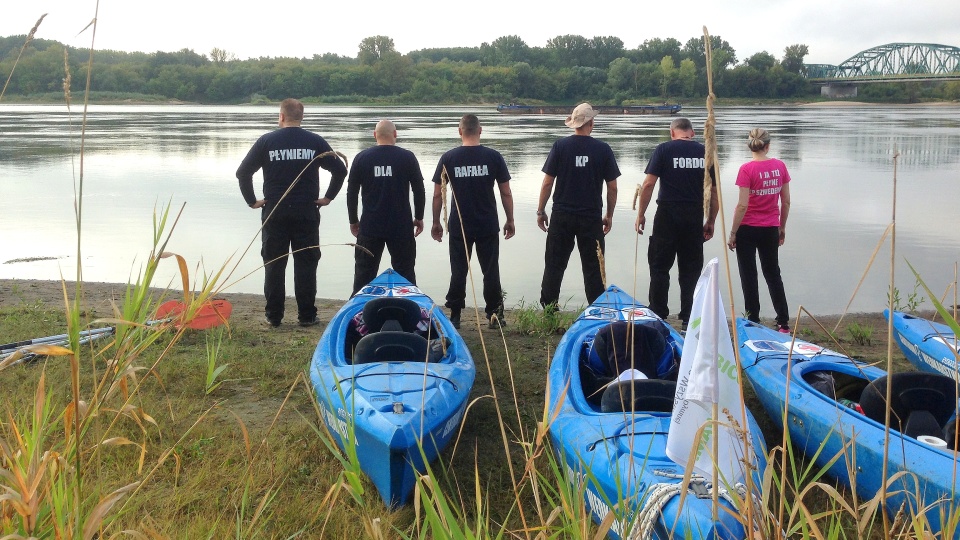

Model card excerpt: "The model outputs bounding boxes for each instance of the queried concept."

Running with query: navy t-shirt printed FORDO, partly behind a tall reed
[643,139,704,204]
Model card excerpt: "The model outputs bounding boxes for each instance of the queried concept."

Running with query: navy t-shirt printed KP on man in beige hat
[543,135,620,218]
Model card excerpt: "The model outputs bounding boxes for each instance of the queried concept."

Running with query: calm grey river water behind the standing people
[0,105,960,317]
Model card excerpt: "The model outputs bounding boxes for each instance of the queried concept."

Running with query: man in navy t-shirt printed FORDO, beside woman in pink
[636,118,720,330]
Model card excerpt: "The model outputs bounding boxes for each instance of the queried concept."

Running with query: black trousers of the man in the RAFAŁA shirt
[446,233,503,319]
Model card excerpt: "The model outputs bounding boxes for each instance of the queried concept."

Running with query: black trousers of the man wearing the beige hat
[540,210,604,306]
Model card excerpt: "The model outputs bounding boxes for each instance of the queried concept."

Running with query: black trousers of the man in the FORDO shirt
[647,202,703,321]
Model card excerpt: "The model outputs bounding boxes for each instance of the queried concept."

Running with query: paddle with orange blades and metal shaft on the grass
[0,298,233,367]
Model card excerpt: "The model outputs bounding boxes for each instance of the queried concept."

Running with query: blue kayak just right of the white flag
[737,319,960,538]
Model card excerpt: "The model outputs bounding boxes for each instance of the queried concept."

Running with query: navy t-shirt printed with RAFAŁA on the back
[433,146,510,237]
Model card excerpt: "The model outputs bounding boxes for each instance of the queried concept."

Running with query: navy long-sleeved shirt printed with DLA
[347,145,425,238]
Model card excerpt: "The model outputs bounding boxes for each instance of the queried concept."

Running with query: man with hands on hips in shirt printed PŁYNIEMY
[237,99,347,327]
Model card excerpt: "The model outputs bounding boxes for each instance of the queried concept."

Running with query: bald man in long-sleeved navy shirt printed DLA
[347,120,426,294]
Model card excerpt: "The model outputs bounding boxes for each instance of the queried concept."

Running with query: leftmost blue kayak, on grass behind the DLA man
[310,269,476,507]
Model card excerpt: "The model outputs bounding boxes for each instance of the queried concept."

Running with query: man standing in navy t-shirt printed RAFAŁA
[430,114,516,328]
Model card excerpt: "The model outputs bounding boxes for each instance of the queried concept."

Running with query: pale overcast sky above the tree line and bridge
[0,0,960,64]
